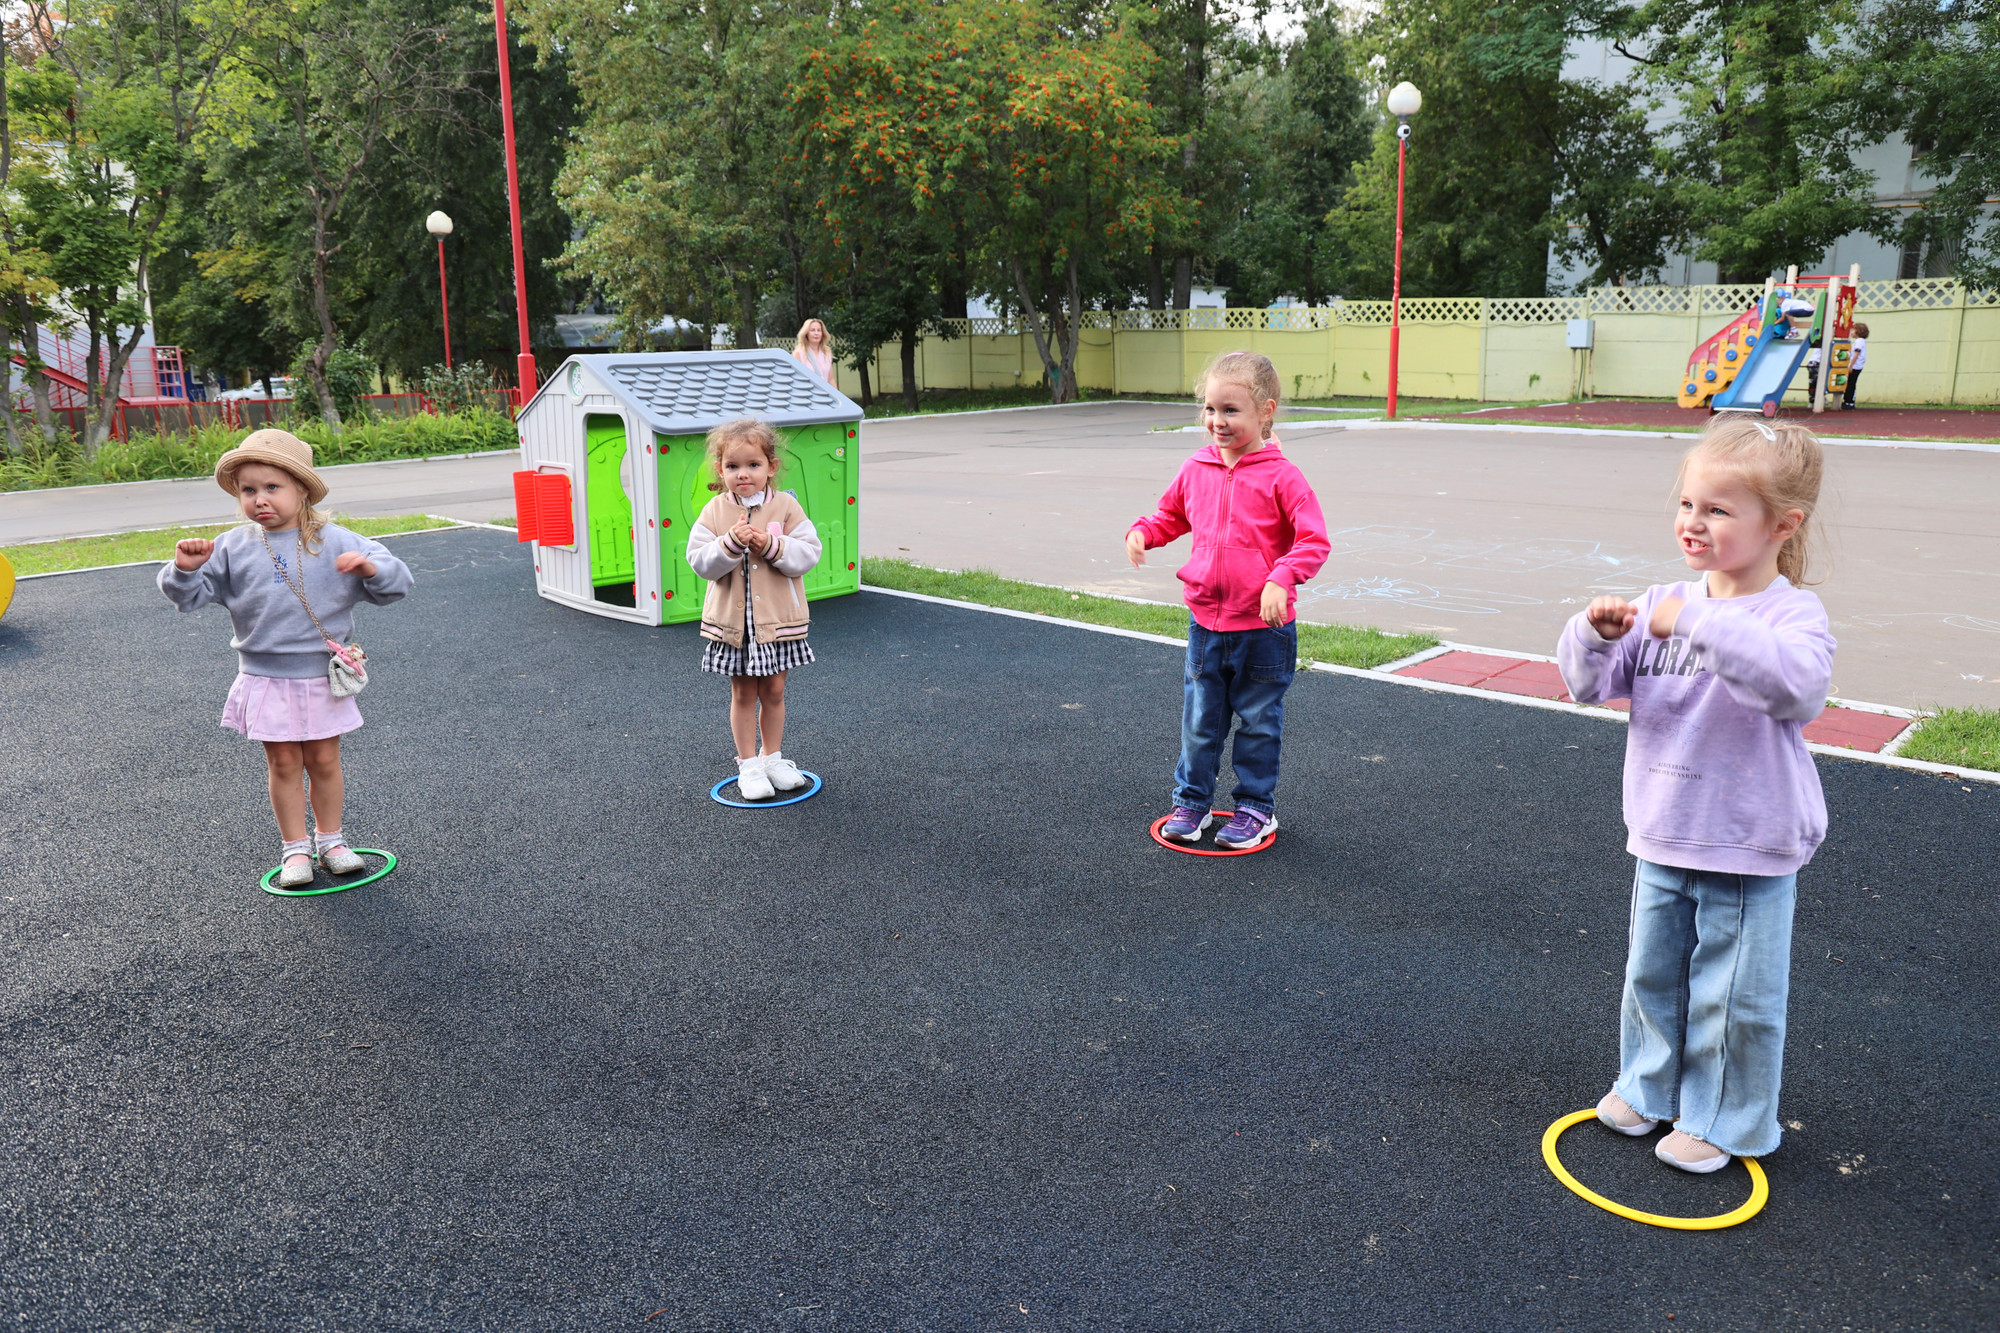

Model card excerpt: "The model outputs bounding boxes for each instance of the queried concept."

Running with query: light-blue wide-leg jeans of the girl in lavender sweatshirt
[1614,861,1798,1157]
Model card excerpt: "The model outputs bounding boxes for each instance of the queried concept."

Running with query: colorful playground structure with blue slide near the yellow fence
[1678,264,1862,416]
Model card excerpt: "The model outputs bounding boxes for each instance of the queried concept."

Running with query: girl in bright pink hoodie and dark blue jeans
[1126,352,1330,849]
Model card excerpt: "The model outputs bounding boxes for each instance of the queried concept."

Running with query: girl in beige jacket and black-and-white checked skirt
[688,416,820,801]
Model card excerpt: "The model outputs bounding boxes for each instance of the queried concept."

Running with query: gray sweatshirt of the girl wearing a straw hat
[160,522,414,681]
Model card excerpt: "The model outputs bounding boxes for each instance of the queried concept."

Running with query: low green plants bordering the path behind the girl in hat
[0,410,518,490]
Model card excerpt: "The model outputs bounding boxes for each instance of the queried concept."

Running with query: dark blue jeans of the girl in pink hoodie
[1174,618,1298,815]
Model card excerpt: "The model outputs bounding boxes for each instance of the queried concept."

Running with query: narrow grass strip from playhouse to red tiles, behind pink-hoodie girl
[862,556,1438,667]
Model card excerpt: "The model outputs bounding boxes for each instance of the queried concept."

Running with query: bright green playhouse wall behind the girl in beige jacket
[654,422,862,624]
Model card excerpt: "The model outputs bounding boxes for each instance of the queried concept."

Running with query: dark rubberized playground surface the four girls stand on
[0,530,2000,1331]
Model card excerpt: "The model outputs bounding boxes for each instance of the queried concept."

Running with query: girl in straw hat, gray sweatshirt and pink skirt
[160,430,412,889]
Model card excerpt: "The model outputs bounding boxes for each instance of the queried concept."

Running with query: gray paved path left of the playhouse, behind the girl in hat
[0,450,520,546]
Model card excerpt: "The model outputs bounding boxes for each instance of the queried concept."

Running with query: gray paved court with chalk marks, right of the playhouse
[862,404,2000,707]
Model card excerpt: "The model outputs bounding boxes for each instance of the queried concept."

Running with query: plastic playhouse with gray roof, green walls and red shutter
[514,348,862,624]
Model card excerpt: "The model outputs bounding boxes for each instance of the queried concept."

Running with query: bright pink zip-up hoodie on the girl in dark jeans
[1132,440,1332,630]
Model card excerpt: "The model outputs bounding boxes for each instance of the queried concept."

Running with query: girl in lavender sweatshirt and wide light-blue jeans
[1556,416,1834,1171]
